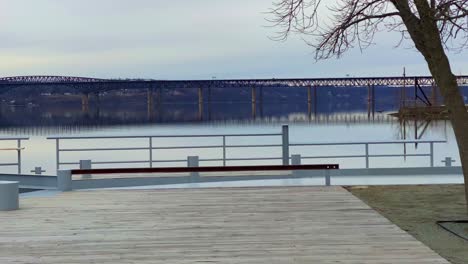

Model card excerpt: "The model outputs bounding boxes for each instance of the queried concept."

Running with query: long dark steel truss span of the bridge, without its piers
[0,76,468,91]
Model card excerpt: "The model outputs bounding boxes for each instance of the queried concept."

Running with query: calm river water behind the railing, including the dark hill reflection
[0,101,459,179]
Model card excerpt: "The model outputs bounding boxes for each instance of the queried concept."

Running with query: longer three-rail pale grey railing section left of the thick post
[47,126,289,170]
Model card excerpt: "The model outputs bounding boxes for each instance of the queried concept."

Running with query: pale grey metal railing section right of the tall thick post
[289,140,447,168]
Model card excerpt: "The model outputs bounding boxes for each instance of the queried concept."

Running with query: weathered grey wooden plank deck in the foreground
[0,187,448,264]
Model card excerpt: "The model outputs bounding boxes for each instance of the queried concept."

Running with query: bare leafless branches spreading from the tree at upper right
[267,0,468,59]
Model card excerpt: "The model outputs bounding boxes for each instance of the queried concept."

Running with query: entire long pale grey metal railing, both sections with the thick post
[48,126,446,170]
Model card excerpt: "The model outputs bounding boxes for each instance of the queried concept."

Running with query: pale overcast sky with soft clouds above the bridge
[0,0,468,79]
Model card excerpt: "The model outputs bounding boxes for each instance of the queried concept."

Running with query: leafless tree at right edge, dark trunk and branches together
[270,0,468,214]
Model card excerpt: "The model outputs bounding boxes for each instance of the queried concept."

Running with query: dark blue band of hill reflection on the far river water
[0,97,394,130]
